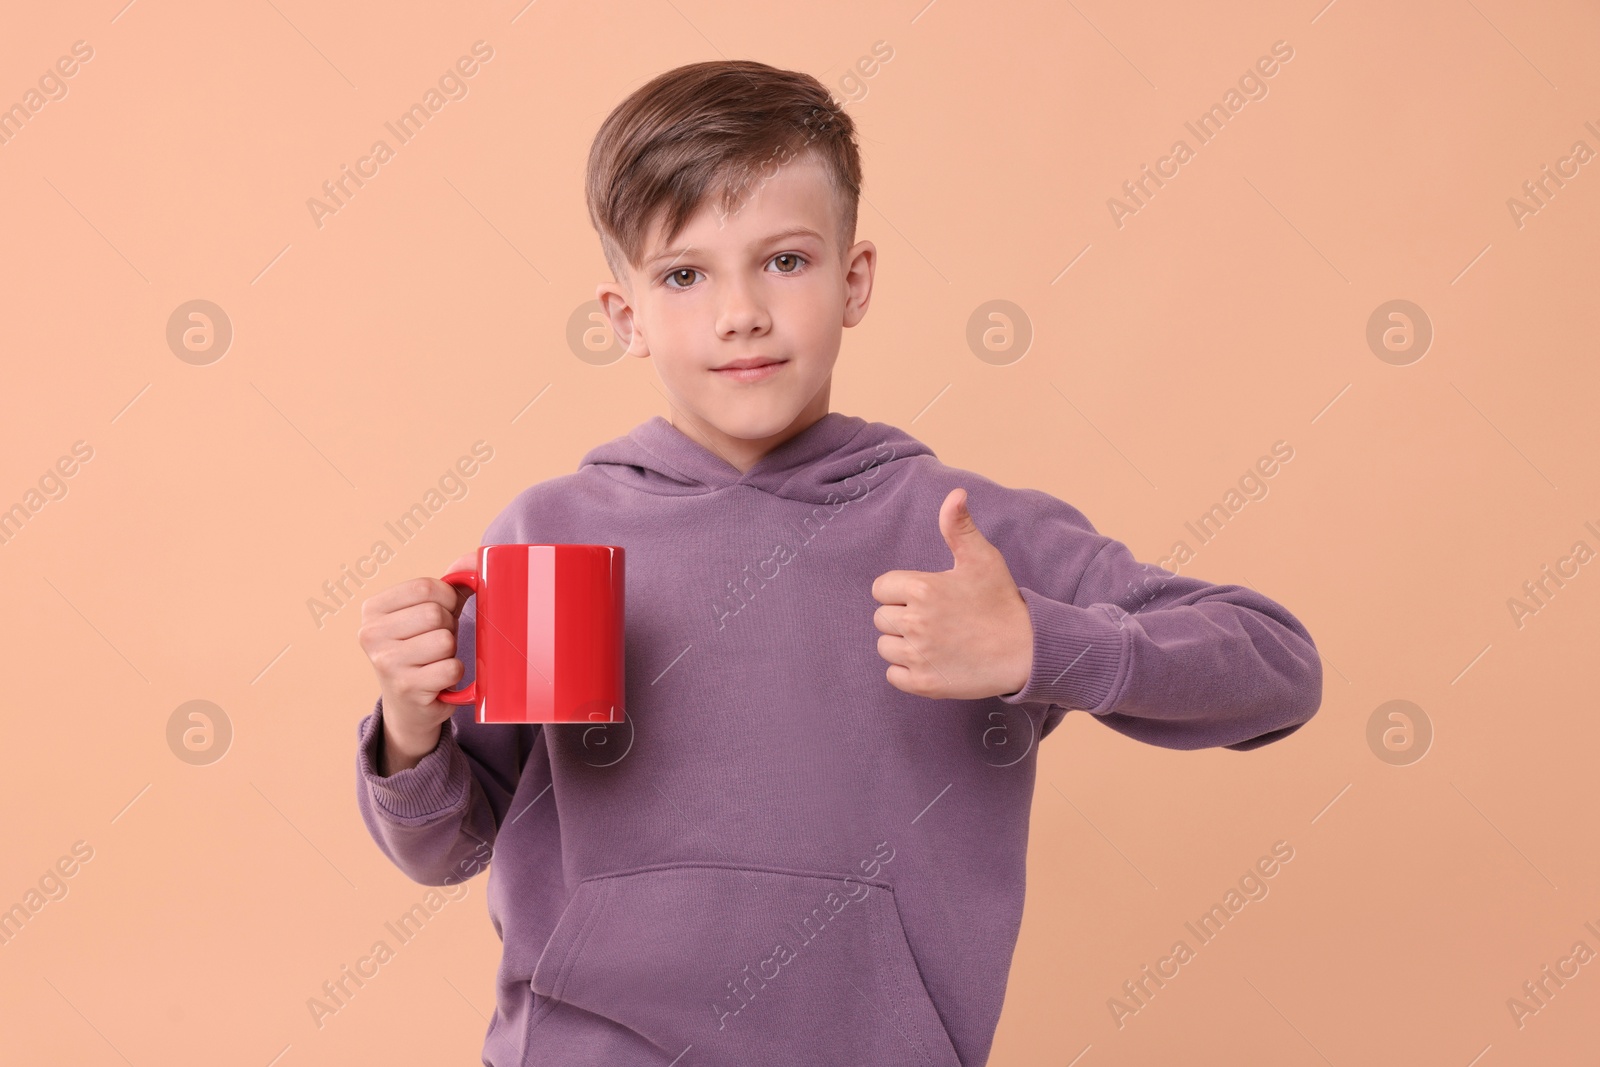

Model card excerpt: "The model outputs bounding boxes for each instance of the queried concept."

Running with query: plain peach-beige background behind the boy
[0,0,1600,1067]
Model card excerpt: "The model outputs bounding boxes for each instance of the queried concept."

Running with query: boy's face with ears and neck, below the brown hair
[595,157,877,472]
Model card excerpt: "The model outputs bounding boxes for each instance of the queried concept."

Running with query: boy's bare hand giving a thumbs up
[872,490,1034,699]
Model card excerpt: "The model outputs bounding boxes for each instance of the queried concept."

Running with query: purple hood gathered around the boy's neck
[579,411,933,504]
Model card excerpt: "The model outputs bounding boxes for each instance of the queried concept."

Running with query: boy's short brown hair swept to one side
[586,59,861,282]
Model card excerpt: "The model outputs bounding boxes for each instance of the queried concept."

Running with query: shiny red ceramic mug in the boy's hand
[438,544,624,723]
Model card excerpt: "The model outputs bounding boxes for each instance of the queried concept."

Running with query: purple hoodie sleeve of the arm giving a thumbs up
[976,494,1322,750]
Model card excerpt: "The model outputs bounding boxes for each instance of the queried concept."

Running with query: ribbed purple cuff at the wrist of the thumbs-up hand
[1000,589,1131,712]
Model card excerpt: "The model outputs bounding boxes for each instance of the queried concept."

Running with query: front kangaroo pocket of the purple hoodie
[533,864,960,1067]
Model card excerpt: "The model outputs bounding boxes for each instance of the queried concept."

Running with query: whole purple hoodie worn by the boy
[357,413,1322,1067]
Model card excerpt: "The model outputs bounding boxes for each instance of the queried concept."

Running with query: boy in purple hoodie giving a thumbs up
[357,61,1322,1067]
